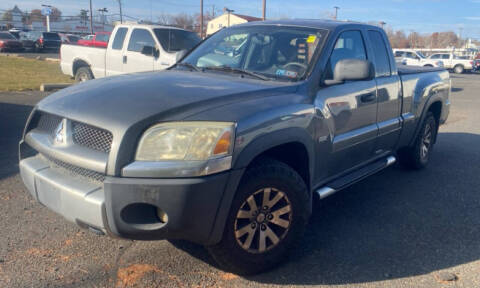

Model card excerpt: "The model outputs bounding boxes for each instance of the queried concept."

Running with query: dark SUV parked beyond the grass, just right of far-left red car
[20,31,62,52]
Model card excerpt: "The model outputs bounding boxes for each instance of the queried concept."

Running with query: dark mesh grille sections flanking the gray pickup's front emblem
[32,112,113,153]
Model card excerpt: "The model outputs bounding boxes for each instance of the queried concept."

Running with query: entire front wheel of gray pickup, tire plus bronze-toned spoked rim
[207,159,309,275]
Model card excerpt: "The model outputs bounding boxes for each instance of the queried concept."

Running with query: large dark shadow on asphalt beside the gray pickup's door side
[174,133,480,285]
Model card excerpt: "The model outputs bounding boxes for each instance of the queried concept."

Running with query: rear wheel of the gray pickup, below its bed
[398,112,438,170]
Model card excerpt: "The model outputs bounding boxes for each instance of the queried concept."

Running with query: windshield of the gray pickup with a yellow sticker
[182,25,327,81]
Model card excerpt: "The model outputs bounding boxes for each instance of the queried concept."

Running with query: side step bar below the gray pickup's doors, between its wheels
[316,156,397,199]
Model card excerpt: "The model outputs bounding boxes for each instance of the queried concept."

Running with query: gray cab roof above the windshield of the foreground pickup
[236,19,380,31]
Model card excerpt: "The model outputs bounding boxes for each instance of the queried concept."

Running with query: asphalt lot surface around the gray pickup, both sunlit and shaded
[0,74,480,287]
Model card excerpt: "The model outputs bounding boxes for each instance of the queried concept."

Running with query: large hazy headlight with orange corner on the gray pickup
[135,121,235,162]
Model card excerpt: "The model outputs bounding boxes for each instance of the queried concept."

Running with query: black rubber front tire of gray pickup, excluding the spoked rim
[207,158,309,275]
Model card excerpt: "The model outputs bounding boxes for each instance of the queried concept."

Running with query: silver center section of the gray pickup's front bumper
[20,155,106,233]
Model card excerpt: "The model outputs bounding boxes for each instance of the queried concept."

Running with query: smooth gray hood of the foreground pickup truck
[37,70,297,130]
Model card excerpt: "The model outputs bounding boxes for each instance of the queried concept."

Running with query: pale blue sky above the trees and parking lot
[0,0,480,40]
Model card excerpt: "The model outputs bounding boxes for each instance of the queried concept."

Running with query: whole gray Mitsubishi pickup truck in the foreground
[20,20,450,274]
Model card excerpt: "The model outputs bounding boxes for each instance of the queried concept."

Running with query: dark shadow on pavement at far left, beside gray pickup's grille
[0,102,33,179]
